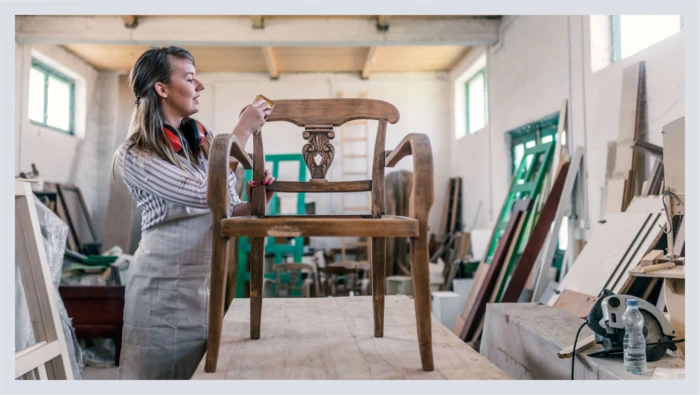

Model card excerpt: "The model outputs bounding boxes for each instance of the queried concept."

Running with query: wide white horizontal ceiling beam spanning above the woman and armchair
[15,15,500,47]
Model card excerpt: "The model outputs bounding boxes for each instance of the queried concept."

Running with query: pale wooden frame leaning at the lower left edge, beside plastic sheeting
[15,181,73,380]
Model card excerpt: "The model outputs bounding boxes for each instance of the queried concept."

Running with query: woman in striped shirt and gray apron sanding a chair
[113,47,274,379]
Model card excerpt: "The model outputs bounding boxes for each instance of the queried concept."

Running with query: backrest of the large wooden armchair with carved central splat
[251,99,399,216]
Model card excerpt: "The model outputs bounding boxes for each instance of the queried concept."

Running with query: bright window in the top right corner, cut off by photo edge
[612,15,681,61]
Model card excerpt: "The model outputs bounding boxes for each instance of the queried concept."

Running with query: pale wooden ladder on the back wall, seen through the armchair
[338,91,372,268]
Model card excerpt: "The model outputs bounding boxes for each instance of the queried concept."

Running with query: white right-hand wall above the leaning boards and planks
[449,16,685,237]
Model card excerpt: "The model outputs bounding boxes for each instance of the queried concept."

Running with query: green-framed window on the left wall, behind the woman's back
[28,59,75,134]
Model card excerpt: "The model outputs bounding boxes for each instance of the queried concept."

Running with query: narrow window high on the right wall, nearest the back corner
[453,52,489,139]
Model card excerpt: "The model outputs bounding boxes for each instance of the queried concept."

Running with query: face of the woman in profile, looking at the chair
[161,56,204,118]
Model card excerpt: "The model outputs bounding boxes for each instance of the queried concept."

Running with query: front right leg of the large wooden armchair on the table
[411,224,433,371]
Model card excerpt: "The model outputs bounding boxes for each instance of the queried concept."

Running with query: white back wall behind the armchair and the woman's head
[117,73,451,251]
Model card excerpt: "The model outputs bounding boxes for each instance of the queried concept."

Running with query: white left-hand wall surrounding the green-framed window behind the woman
[15,44,118,240]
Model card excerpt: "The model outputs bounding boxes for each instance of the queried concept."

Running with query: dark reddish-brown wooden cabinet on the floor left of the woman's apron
[58,285,124,365]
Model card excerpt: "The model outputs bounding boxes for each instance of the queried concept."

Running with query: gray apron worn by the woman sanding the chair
[119,203,211,380]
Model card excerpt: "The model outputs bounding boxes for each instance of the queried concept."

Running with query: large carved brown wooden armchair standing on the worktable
[204,99,433,372]
